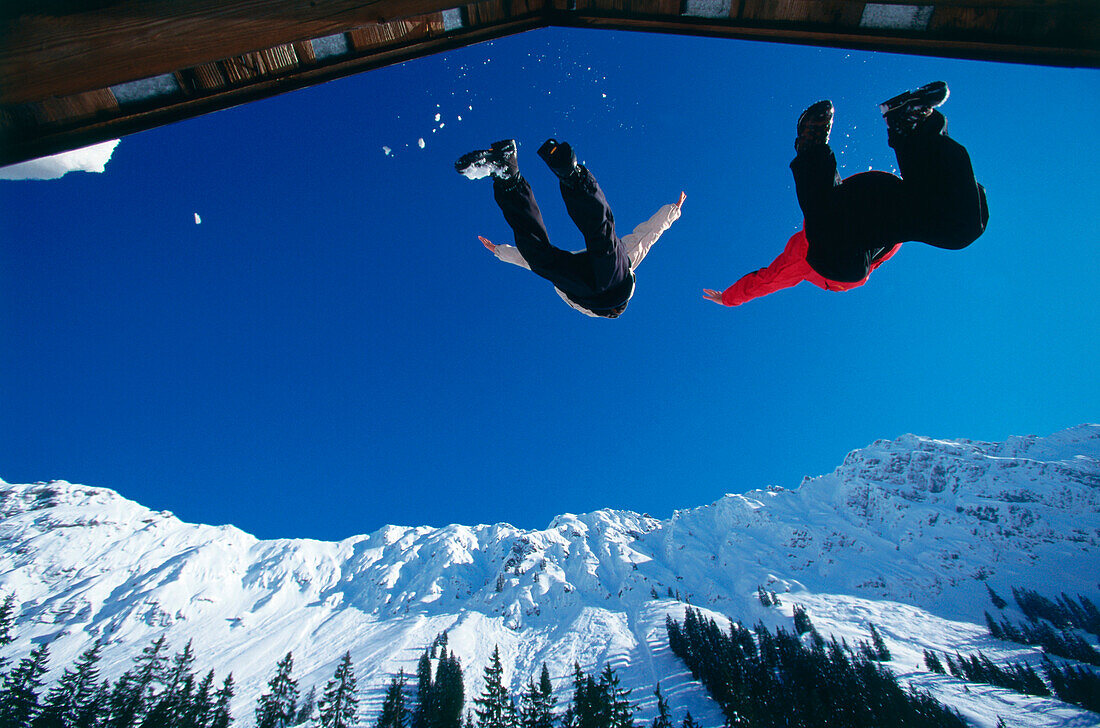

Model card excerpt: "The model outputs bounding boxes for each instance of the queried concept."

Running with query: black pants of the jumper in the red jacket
[791,111,989,282]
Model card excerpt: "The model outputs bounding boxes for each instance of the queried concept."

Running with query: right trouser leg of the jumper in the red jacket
[890,111,989,250]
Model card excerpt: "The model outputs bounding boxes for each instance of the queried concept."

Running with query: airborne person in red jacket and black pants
[704,81,989,306]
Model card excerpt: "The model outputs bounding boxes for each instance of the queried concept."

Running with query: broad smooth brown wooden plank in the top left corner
[0,0,499,103]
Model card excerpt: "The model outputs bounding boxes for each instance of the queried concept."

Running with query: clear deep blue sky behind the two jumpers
[0,29,1100,539]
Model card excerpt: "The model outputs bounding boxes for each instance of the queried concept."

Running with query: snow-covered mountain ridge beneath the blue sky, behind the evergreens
[0,424,1100,726]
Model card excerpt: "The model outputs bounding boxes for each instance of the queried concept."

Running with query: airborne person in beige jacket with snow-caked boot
[454,139,684,319]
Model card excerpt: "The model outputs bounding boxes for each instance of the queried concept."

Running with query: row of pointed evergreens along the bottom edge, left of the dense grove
[0,595,660,728]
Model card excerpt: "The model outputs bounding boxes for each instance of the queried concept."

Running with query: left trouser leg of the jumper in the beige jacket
[493,177,592,293]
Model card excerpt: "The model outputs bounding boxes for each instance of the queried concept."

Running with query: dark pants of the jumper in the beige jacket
[493,167,634,312]
